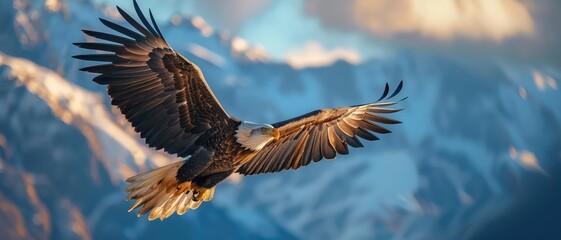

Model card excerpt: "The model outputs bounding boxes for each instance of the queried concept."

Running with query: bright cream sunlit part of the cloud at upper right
[352,0,534,41]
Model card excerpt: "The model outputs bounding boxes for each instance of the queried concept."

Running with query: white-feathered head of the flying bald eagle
[236,121,280,151]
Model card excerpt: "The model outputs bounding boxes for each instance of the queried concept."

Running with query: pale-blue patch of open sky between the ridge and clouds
[96,0,387,60]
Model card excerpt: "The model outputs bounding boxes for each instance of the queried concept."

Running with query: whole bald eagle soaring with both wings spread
[73,1,403,220]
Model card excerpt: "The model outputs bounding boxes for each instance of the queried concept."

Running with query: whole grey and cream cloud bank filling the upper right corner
[304,0,561,68]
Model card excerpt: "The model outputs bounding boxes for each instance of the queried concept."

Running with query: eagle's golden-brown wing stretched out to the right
[238,82,405,175]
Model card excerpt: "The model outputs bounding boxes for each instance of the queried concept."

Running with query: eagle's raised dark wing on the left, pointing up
[74,1,237,157]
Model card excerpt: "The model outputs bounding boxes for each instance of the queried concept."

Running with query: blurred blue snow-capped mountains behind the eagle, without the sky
[0,0,561,239]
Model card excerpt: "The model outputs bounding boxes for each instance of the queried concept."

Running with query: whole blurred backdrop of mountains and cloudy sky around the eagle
[0,0,561,239]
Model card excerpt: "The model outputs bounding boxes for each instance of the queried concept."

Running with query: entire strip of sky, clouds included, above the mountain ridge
[96,0,561,67]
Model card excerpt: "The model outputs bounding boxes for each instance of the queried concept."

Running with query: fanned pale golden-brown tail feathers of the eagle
[125,161,214,220]
